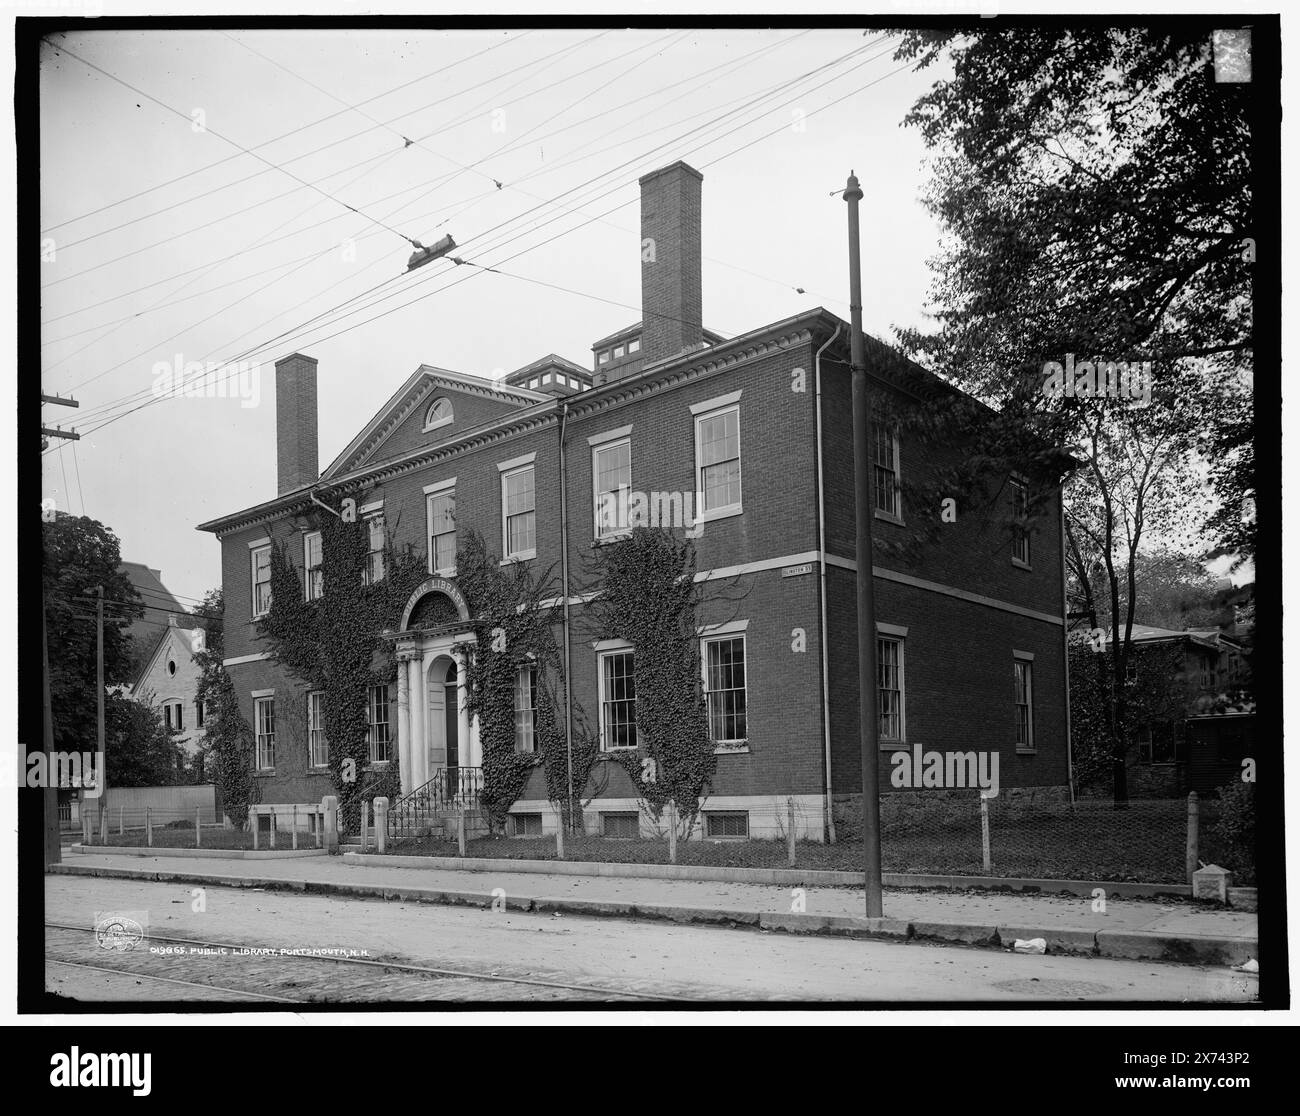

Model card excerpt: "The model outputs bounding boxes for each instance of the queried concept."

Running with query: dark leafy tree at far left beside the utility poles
[42,514,144,752]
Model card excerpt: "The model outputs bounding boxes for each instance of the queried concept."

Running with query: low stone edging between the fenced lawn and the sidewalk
[343,852,1222,909]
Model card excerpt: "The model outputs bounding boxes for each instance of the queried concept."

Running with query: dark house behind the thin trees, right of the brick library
[1105,624,1255,797]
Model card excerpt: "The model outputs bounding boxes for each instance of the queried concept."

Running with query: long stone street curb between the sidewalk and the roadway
[47,864,1258,965]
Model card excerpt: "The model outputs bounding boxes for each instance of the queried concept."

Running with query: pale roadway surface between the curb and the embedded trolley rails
[46,875,1257,1004]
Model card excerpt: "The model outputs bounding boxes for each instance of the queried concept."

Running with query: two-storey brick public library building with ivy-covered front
[199,156,1067,839]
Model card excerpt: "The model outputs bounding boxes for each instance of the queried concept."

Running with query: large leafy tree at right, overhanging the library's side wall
[900,26,1253,803]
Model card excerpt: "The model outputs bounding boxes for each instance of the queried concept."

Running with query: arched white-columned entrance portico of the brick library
[394,578,482,795]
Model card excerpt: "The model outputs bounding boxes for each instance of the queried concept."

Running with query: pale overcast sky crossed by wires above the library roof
[40,29,943,600]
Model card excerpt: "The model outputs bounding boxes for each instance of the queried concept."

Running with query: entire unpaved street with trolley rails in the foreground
[46,875,1258,1004]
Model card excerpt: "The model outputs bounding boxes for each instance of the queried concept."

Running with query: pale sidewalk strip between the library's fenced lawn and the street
[51,852,1258,965]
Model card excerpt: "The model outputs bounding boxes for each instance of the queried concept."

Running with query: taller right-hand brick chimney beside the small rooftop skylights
[641,161,705,367]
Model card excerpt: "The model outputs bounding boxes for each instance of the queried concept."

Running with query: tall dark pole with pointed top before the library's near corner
[844,170,884,918]
